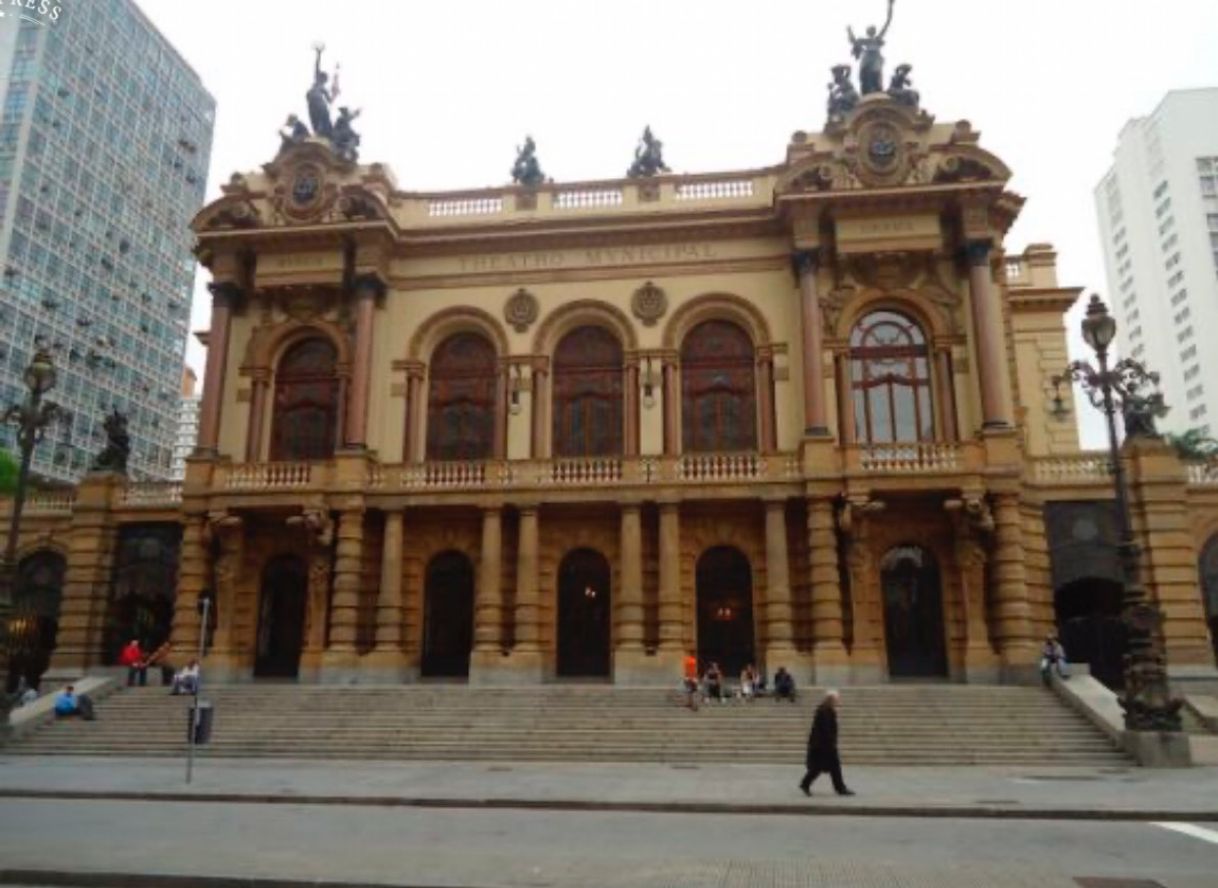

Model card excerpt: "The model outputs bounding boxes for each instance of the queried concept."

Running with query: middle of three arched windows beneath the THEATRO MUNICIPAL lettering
[554,326,622,457]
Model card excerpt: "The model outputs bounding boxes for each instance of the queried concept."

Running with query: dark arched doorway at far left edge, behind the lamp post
[6,551,67,692]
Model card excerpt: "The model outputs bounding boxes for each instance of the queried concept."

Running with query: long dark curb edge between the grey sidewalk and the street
[0,789,1218,818]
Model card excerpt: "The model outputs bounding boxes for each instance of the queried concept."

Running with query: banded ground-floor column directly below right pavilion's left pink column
[808,498,850,685]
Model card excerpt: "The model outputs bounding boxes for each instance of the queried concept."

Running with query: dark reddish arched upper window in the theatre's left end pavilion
[270,337,339,460]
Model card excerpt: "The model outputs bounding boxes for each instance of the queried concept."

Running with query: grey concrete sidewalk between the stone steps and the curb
[0,756,1218,821]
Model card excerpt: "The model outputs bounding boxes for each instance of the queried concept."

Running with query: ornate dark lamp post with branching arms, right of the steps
[1052,295,1181,731]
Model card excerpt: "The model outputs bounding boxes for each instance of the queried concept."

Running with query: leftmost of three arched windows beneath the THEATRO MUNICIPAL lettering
[428,333,497,459]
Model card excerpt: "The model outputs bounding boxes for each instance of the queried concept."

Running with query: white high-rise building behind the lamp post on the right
[1095,88,1218,436]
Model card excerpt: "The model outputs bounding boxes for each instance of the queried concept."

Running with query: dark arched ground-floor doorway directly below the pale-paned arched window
[879,546,948,678]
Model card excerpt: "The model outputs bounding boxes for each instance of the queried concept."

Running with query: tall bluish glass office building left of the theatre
[0,0,216,481]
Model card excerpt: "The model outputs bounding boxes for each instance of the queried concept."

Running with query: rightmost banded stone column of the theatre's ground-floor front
[990,493,1038,681]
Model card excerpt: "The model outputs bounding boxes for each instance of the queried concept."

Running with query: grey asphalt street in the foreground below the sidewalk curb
[0,799,1218,888]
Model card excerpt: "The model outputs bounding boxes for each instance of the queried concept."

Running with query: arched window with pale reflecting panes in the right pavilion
[850,311,934,443]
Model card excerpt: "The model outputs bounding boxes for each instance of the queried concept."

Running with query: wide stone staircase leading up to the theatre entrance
[7,685,1130,766]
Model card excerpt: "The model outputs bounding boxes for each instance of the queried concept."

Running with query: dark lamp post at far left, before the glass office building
[0,347,63,738]
